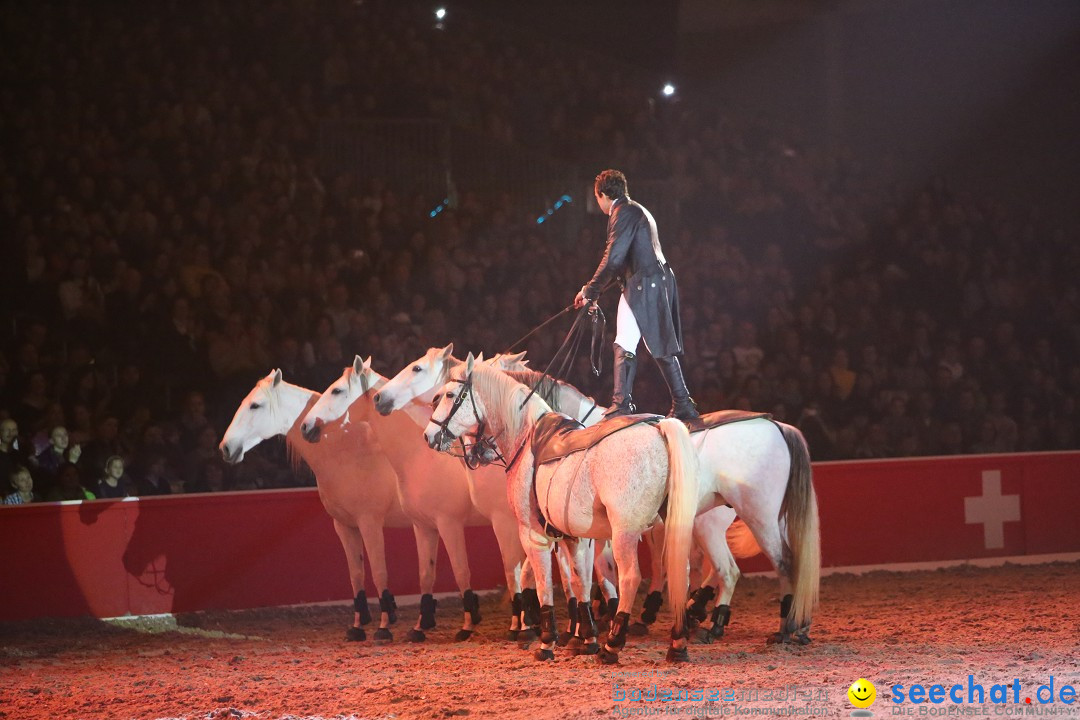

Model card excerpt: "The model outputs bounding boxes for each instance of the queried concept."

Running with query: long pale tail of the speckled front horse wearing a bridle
[658,418,698,639]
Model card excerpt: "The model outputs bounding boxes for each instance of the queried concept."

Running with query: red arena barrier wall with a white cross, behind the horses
[0,452,1080,620]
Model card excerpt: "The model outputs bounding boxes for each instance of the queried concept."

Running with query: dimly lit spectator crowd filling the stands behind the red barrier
[0,0,1080,503]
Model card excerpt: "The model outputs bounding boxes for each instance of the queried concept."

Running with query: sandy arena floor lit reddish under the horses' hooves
[0,562,1080,720]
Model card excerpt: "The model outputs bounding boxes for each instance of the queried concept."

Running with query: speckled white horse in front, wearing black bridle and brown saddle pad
[424,354,700,663]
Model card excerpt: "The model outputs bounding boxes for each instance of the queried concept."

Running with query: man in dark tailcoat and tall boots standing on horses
[573,169,700,424]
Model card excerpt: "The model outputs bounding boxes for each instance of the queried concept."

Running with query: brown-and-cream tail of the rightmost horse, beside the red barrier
[778,423,821,628]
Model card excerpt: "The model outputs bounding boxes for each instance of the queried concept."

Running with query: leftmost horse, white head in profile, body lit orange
[219,370,411,642]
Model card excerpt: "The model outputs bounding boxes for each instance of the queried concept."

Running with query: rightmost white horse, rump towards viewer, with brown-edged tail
[503,369,821,644]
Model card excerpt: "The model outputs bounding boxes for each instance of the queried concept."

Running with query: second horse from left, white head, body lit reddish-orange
[300,355,528,641]
